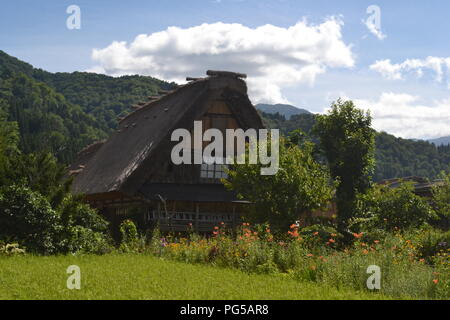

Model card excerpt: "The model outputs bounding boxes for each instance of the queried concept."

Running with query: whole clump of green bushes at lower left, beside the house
[0,185,110,254]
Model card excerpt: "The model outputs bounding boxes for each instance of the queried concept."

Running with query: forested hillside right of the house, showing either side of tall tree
[262,113,450,181]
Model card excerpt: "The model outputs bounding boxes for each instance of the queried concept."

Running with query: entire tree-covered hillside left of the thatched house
[0,51,174,163]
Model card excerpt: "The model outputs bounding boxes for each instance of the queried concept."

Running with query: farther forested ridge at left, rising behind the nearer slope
[0,50,176,133]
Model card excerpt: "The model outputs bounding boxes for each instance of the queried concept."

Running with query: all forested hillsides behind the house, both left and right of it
[0,51,450,180]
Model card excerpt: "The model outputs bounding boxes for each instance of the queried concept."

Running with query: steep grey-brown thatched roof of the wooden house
[72,72,263,195]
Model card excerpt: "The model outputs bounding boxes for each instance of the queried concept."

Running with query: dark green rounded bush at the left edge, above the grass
[0,185,63,254]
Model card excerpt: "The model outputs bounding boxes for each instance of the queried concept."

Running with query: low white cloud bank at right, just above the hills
[346,92,450,139]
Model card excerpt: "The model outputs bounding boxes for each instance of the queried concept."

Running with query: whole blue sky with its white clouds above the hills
[0,0,450,138]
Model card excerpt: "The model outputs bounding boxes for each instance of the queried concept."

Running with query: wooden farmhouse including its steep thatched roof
[70,71,263,232]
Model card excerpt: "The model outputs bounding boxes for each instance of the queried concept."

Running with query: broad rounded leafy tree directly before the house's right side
[223,139,333,230]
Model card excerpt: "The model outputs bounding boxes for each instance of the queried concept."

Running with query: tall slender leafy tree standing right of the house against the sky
[314,100,375,234]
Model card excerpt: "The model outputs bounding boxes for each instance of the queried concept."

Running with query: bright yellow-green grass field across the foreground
[0,254,386,300]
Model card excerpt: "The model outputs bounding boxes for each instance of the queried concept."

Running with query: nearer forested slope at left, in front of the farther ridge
[0,73,107,163]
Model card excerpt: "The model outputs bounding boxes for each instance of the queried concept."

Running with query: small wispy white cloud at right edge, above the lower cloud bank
[370,56,450,85]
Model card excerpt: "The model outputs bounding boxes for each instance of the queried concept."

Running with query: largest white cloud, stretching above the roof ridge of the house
[91,18,354,103]
